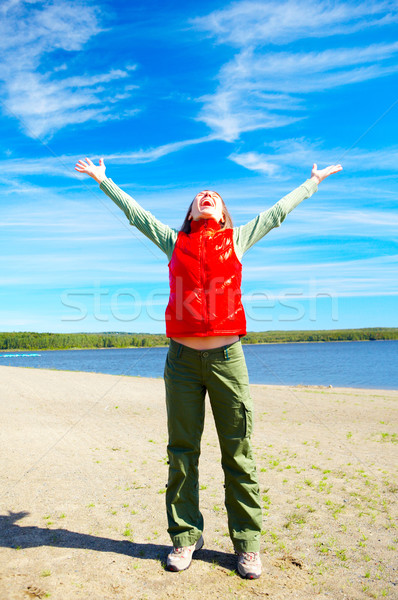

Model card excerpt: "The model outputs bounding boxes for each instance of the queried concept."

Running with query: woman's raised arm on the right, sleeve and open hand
[234,163,343,260]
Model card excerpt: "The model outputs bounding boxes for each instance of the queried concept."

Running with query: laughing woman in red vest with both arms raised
[75,158,342,579]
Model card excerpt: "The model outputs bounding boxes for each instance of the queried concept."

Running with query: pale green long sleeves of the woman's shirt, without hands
[100,178,318,261]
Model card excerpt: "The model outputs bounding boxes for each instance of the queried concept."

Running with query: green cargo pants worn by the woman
[164,340,262,552]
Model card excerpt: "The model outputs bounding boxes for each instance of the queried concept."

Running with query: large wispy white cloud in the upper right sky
[192,0,398,142]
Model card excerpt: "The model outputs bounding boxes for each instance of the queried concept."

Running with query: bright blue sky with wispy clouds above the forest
[0,0,398,332]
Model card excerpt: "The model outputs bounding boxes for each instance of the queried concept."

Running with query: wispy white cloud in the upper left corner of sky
[0,0,138,139]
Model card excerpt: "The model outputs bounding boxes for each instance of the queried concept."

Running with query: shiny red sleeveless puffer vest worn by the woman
[166,219,246,337]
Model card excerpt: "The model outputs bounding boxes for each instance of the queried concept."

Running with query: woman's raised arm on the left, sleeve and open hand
[75,158,178,260]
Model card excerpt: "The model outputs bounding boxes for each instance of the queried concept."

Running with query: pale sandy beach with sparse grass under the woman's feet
[0,367,398,600]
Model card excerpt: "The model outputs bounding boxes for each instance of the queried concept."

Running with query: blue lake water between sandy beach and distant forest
[0,340,398,389]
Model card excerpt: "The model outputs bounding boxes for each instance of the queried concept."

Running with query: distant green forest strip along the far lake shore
[0,327,398,350]
